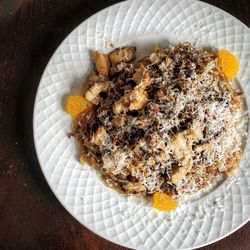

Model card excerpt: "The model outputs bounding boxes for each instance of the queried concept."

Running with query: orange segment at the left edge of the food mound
[65,96,92,117]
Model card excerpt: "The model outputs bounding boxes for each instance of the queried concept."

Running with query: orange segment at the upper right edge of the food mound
[218,49,239,80]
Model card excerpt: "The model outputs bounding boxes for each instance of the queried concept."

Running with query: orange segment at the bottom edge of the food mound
[153,192,177,211]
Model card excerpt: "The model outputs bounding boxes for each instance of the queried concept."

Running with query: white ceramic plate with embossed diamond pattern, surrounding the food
[34,0,250,249]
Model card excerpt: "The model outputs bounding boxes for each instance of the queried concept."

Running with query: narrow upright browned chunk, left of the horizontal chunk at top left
[93,51,110,76]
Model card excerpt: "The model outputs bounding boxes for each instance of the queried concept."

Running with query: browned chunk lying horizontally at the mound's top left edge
[109,46,136,65]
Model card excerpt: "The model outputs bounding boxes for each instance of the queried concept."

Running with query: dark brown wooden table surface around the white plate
[0,0,250,250]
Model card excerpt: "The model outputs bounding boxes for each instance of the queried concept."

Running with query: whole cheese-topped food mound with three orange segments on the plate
[66,43,242,210]
